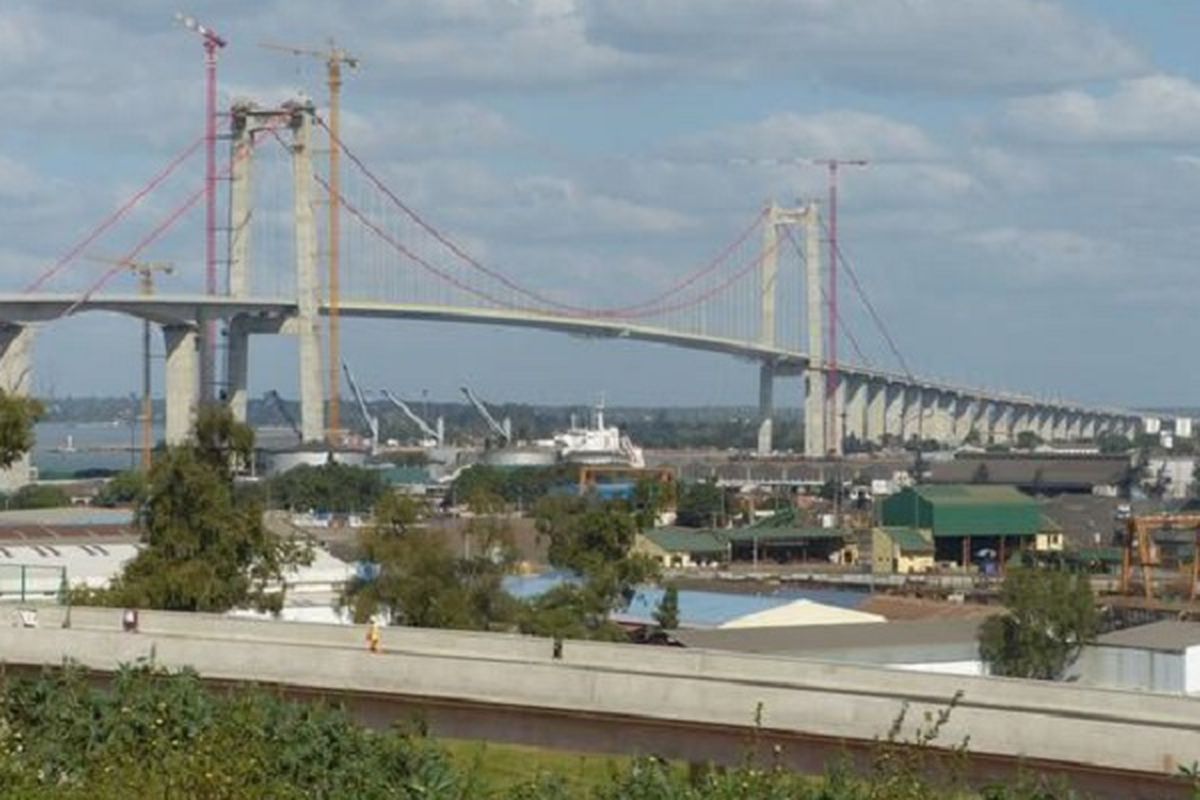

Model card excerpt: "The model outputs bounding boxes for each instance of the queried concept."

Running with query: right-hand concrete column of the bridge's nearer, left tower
[292,104,325,443]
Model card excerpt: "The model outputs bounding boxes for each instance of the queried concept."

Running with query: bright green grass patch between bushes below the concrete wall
[440,739,631,796]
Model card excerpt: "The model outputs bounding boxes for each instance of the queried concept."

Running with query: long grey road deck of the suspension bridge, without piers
[0,294,1128,416]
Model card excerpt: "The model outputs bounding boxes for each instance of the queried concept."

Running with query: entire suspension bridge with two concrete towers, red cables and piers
[0,101,1141,457]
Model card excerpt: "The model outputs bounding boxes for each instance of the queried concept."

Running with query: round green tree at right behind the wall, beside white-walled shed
[979,567,1097,680]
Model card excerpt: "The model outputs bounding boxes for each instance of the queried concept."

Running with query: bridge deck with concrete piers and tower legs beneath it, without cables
[0,294,1140,456]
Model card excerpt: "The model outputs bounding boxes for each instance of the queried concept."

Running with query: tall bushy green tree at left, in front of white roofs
[86,407,311,612]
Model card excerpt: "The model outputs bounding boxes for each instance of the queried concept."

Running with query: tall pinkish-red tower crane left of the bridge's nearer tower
[175,12,228,402]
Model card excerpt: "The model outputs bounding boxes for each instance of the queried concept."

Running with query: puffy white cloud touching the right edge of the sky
[1003,74,1200,144]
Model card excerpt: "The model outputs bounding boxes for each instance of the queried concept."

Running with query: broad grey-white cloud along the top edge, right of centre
[582,0,1146,90]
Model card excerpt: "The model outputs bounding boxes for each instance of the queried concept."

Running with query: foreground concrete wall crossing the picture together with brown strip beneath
[0,606,1200,798]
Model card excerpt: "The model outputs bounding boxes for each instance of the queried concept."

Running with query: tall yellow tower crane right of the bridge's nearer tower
[259,40,359,444]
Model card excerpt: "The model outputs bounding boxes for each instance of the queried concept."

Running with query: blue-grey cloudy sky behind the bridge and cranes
[0,0,1200,405]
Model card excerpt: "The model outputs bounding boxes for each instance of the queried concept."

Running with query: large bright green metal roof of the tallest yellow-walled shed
[881,483,1043,537]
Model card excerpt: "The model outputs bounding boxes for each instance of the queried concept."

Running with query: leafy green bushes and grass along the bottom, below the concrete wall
[0,664,1132,800]
